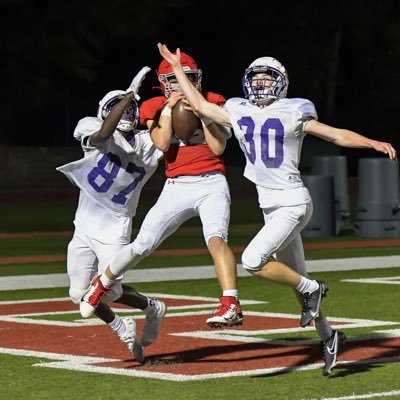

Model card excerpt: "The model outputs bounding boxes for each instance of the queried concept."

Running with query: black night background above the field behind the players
[0,0,400,169]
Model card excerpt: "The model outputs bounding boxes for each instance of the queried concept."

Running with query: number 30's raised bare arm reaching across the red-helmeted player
[157,43,231,126]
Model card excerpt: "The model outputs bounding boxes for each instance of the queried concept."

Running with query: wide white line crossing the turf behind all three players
[0,256,400,291]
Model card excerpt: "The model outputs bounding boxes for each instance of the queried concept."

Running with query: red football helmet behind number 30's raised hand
[156,52,202,97]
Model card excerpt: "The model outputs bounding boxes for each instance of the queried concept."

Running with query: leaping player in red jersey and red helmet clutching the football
[81,53,243,328]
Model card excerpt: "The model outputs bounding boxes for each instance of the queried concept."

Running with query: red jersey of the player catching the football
[140,92,226,178]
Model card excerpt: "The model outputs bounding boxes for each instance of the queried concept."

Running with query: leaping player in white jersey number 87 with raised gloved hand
[57,67,166,362]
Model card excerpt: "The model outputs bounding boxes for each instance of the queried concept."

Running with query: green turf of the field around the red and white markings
[0,192,400,400]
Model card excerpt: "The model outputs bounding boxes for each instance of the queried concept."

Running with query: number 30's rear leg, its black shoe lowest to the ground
[276,234,346,375]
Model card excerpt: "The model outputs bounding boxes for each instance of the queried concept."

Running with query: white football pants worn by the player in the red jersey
[110,172,231,275]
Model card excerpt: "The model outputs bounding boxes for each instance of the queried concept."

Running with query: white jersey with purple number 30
[224,98,318,189]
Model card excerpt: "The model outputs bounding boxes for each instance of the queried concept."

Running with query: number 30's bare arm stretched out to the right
[305,120,397,160]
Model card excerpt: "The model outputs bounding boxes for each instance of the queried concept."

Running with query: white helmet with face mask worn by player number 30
[242,57,289,104]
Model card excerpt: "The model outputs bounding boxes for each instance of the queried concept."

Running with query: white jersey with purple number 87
[57,117,163,243]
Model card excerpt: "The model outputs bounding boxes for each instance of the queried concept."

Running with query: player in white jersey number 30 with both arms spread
[158,43,397,376]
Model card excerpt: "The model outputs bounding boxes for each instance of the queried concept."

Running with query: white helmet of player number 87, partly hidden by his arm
[97,90,139,132]
